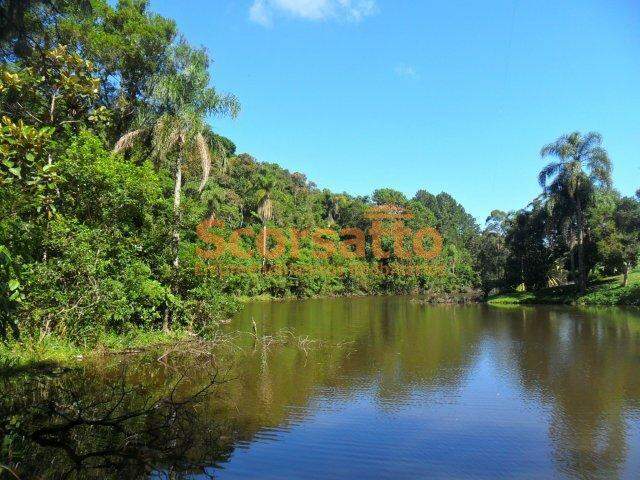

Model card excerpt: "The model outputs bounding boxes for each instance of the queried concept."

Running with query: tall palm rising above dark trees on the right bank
[538,132,611,293]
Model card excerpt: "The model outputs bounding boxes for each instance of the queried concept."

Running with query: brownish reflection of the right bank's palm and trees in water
[498,308,640,478]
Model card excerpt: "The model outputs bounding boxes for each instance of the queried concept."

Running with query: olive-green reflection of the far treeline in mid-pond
[228,298,482,428]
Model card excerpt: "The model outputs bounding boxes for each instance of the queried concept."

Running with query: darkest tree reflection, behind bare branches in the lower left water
[0,370,235,479]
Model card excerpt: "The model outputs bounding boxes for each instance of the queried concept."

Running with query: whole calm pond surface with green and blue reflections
[0,297,640,479]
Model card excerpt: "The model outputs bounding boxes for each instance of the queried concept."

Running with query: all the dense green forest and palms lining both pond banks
[0,0,640,352]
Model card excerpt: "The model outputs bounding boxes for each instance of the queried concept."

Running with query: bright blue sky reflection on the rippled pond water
[211,326,640,479]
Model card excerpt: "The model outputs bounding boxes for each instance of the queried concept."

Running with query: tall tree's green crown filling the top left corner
[0,0,177,138]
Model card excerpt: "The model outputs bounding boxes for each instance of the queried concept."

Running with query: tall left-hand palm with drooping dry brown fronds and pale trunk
[114,41,239,326]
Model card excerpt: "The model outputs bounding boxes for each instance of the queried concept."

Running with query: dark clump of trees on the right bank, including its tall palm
[477,132,640,298]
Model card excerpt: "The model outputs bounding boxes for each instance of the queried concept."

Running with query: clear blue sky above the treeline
[152,0,640,221]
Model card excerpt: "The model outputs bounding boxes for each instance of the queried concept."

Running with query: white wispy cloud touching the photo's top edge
[249,0,378,26]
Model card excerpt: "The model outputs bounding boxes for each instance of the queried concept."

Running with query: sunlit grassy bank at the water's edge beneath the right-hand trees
[488,270,640,306]
